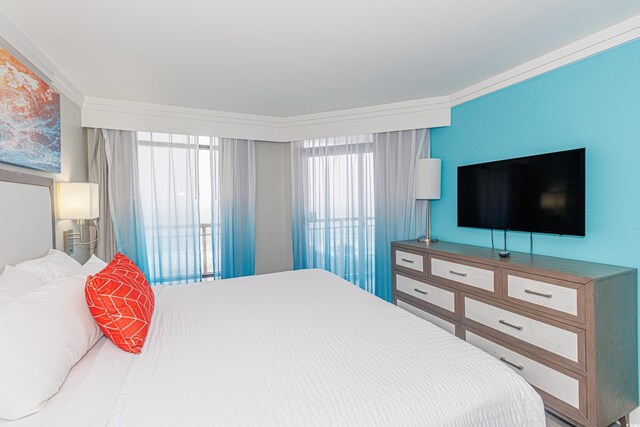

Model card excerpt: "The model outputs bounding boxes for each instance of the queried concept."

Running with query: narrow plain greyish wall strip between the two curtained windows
[256,141,293,274]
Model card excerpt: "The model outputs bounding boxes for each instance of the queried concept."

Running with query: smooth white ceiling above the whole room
[2,0,640,117]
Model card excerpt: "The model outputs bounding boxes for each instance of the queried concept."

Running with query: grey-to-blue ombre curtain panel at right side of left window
[220,138,256,279]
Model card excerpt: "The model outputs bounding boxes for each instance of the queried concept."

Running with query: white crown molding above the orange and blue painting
[0,11,84,107]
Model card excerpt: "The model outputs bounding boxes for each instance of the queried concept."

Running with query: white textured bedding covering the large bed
[5,270,545,427]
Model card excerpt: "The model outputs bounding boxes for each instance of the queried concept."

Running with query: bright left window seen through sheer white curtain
[137,132,222,283]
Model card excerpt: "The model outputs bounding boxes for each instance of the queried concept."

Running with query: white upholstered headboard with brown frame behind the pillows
[0,169,56,272]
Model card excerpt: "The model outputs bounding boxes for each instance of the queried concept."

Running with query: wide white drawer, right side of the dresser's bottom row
[466,331,580,409]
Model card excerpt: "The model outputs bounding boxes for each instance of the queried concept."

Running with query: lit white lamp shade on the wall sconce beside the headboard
[58,182,99,219]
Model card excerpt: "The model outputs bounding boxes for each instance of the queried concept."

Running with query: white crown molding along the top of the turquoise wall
[449,15,640,107]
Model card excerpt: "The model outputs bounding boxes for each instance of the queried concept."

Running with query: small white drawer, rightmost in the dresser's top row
[507,274,578,316]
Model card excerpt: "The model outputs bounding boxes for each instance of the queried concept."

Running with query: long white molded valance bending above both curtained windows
[82,96,451,142]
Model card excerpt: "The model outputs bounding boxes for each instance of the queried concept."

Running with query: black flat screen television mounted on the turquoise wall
[458,148,585,236]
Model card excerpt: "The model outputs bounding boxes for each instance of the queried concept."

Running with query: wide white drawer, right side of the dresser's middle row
[464,297,579,362]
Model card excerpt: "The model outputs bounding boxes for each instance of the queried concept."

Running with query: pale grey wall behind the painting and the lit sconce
[0,95,89,262]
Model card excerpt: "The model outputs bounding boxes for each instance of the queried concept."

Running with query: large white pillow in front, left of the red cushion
[0,276,101,420]
